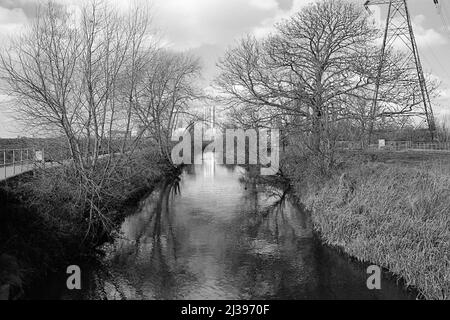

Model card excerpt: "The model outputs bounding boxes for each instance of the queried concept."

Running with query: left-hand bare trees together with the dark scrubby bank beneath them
[0,0,201,298]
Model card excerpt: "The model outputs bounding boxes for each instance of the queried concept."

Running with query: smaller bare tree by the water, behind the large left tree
[134,49,202,162]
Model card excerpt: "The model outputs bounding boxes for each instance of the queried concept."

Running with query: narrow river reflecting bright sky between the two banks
[29,154,415,299]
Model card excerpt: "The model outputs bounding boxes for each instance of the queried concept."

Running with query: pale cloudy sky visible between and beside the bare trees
[0,0,450,137]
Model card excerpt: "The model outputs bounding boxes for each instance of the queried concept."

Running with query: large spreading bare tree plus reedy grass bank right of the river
[216,0,450,299]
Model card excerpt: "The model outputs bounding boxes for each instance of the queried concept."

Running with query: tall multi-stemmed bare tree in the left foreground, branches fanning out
[0,0,162,239]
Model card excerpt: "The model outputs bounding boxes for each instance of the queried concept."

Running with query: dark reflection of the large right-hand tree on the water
[227,174,318,298]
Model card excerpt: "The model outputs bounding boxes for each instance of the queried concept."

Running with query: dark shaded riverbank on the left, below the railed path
[0,151,179,299]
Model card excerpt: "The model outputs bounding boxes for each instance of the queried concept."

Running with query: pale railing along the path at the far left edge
[0,148,45,180]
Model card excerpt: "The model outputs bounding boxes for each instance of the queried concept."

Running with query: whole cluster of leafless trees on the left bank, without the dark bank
[0,0,199,238]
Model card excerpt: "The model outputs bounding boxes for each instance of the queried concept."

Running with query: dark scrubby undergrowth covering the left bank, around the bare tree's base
[0,146,177,298]
